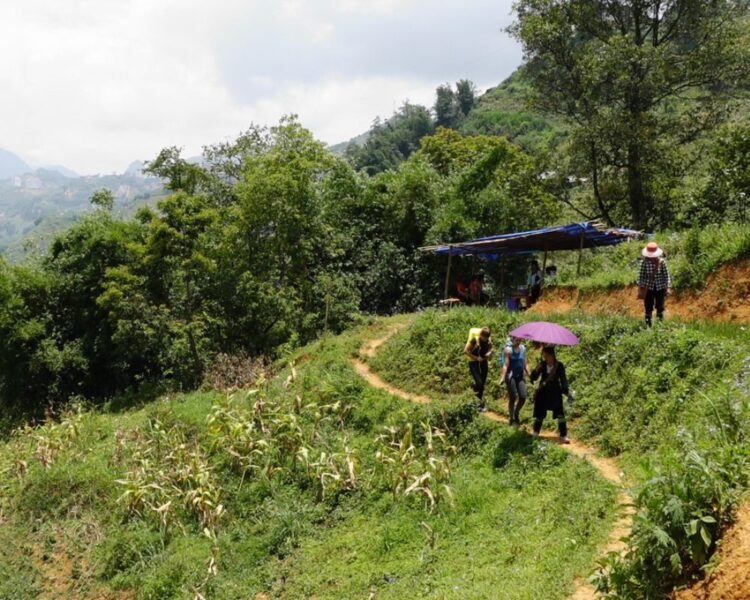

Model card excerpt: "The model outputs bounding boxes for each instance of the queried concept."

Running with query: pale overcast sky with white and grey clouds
[0,0,521,174]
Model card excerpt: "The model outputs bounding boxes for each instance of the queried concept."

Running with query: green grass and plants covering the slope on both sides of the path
[0,309,750,599]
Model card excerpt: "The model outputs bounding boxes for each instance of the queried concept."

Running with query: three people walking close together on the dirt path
[464,327,573,444]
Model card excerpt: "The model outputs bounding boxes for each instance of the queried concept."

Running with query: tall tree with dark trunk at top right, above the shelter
[510,0,748,228]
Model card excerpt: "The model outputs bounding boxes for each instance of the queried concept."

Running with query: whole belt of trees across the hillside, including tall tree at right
[0,0,750,422]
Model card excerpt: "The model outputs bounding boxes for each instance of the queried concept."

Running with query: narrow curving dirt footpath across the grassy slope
[351,324,633,600]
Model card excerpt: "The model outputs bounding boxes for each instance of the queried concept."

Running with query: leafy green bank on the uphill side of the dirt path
[371,308,750,598]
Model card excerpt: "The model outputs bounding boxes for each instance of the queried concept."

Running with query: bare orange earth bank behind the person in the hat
[529,259,750,323]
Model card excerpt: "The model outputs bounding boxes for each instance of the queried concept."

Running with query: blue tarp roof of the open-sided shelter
[420,221,642,260]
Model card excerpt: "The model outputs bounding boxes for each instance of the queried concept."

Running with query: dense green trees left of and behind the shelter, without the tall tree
[0,117,559,408]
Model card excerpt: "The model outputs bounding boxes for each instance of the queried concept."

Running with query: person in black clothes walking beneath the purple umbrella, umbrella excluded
[531,346,571,444]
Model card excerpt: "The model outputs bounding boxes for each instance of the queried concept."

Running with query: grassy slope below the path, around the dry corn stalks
[0,322,615,599]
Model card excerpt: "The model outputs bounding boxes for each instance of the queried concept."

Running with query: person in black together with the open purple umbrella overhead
[510,321,579,444]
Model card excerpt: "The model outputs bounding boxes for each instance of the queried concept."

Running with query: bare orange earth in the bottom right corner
[673,503,750,600]
